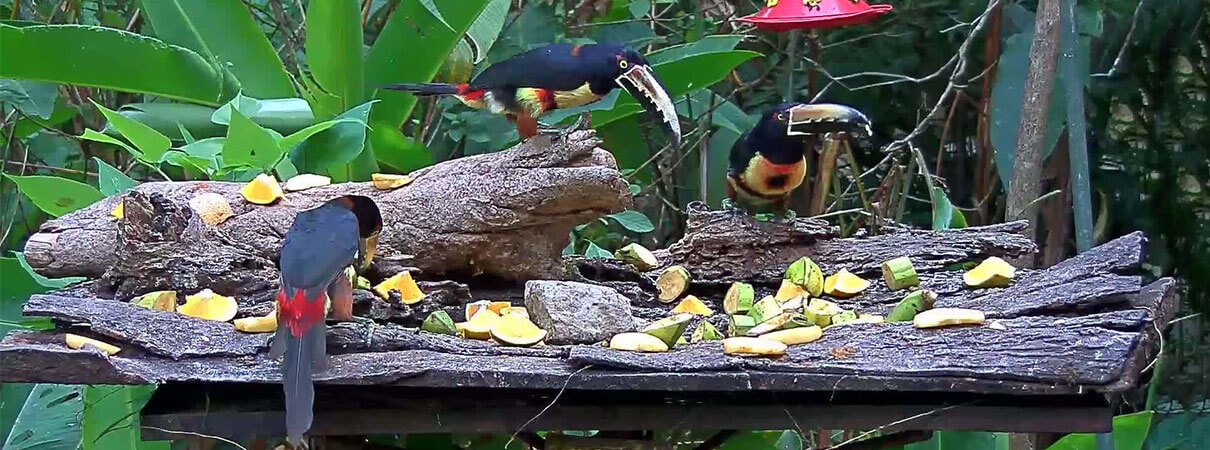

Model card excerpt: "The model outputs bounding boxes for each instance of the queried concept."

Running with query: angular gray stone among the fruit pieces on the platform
[525,279,635,344]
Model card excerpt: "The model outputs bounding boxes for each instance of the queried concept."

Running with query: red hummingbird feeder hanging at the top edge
[739,0,892,31]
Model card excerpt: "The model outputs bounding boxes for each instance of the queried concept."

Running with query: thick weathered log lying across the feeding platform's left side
[25,132,630,298]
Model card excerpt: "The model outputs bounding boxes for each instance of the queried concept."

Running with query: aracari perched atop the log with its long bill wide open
[380,44,681,145]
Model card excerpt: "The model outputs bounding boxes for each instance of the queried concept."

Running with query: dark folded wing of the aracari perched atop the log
[469,44,589,91]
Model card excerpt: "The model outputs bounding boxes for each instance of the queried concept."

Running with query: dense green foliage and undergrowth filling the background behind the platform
[0,0,1210,449]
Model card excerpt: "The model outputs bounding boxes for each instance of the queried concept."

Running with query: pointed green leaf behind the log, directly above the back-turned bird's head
[282,102,374,176]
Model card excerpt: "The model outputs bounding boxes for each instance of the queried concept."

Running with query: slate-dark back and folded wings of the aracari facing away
[280,203,357,289]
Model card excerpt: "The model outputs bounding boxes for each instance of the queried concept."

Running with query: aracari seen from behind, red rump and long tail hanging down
[269,196,382,445]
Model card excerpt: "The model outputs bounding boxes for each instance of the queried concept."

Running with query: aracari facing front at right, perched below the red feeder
[724,102,871,219]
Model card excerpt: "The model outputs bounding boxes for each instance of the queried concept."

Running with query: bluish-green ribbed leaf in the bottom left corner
[4,383,83,450]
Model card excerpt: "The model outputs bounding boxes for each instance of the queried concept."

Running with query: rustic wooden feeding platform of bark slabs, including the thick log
[0,132,1179,439]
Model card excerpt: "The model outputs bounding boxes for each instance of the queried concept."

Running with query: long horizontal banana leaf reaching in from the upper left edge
[0,24,238,105]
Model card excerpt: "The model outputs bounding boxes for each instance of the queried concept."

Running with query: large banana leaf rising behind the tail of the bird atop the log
[365,0,490,171]
